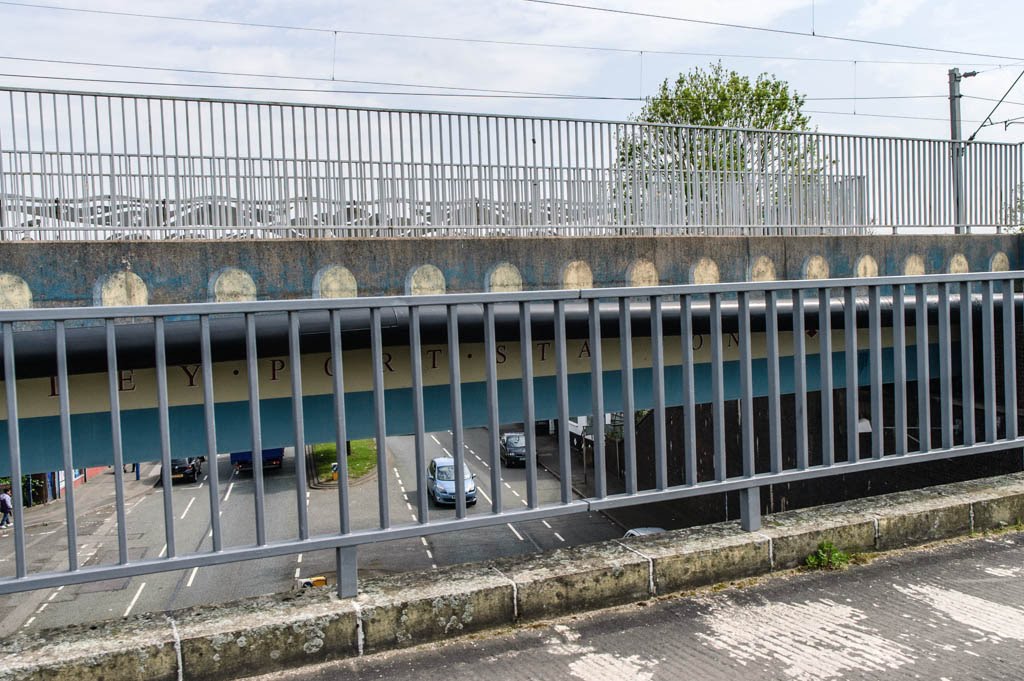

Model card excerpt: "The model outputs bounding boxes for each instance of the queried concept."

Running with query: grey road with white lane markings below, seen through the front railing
[0,429,623,635]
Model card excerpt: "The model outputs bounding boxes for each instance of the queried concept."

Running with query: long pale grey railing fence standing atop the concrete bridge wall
[0,88,1022,240]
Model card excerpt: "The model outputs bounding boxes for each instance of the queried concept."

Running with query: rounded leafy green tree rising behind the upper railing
[615,63,834,224]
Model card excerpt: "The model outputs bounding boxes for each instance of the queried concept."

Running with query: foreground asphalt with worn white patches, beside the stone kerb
[254,533,1024,681]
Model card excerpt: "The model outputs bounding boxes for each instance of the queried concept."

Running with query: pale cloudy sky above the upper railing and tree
[0,0,1024,142]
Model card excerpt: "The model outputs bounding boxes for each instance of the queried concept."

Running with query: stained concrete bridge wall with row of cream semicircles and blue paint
[0,235,1024,308]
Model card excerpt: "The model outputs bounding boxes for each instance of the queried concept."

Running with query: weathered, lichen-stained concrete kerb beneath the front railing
[6,473,1024,681]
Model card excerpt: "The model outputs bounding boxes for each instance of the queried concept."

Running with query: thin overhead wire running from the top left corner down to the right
[0,0,1008,68]
